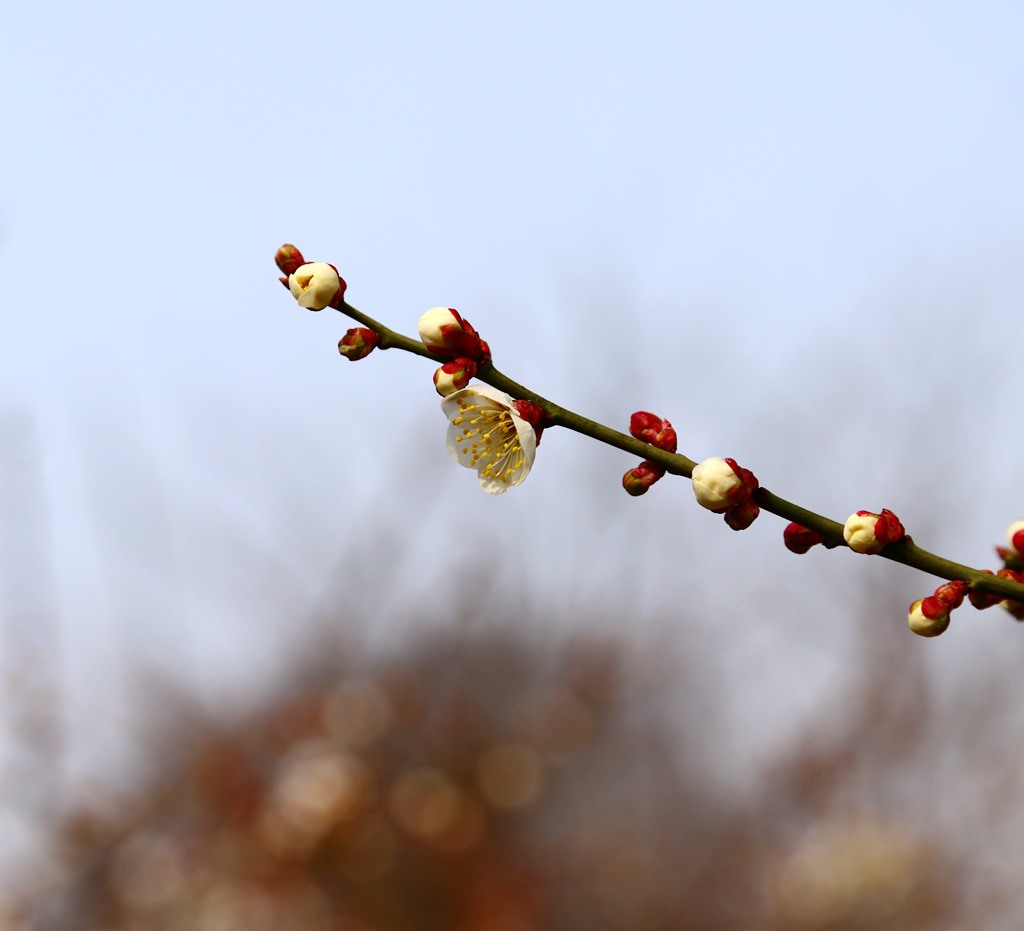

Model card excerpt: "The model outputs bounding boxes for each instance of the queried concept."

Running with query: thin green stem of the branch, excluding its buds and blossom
[338,302,1024,601]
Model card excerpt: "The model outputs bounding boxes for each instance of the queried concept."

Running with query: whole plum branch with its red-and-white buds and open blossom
[274,244,1024,636]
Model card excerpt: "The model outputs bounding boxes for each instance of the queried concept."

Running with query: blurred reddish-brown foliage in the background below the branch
[0,602,985,931]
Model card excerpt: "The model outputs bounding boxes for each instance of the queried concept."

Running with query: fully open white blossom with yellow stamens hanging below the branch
[441,385,537,495]
